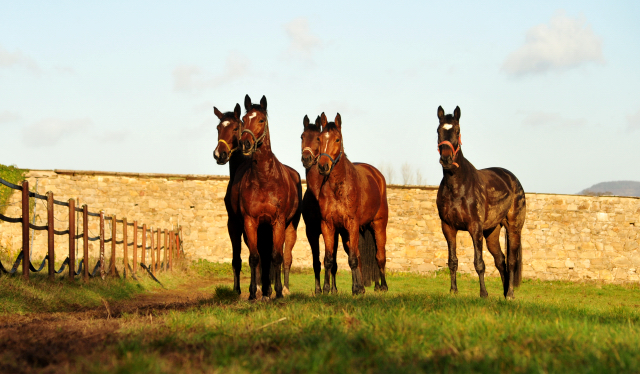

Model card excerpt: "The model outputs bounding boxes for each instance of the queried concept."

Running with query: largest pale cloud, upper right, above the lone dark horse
[502,12,604,76]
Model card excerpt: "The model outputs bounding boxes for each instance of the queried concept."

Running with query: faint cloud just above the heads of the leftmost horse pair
[173,52,249,92]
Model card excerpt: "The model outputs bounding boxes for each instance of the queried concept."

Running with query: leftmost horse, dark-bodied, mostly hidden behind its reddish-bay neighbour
[213,104,250,294]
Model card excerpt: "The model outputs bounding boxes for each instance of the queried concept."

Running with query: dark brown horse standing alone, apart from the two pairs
[436,106,526,299]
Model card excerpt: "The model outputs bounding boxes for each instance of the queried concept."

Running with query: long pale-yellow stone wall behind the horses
[0,170,640,282]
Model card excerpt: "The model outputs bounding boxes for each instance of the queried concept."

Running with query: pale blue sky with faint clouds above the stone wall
[0,0,640,193]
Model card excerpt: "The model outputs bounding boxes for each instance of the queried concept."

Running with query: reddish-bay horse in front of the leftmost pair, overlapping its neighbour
[239,95,302,300]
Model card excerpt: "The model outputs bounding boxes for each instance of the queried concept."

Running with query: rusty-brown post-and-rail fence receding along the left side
[0,178,182,280]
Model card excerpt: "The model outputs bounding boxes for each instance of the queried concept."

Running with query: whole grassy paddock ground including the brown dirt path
[0,262,640,373]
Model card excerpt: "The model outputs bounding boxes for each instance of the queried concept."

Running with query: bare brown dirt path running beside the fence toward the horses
[0,279,233,373]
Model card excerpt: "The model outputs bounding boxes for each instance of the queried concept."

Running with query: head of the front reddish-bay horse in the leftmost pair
[240,95,269,156]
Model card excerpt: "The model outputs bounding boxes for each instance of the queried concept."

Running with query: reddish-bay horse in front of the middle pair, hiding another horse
[318,113,389,295]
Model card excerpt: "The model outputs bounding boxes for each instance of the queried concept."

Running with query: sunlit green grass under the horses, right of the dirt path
[82,265,640,373]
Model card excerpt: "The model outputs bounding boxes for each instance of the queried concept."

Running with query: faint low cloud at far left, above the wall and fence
[22,118,91,147]
